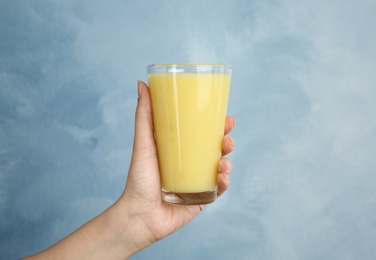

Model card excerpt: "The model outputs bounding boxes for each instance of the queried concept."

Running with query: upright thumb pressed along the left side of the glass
[133,81,155,157]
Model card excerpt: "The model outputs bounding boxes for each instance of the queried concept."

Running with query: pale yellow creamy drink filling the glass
[148,73,231,193]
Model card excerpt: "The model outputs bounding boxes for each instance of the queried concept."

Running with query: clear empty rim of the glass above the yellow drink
[146,63,232,74]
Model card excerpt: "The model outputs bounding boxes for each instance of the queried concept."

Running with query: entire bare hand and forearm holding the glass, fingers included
[24,81,235,260]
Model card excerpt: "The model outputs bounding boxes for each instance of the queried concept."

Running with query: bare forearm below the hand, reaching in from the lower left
[25,198,150,260]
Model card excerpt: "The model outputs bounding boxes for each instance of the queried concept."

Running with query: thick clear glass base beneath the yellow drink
[162,189,217,205]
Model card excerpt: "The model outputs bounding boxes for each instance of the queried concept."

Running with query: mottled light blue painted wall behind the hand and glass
[0,0,376,260]
